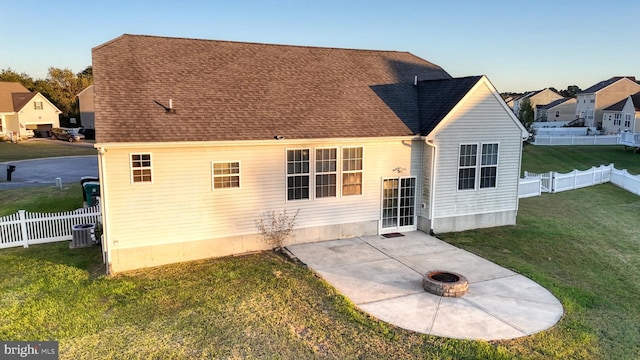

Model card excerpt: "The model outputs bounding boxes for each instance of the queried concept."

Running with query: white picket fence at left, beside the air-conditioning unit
[0,206,102,249]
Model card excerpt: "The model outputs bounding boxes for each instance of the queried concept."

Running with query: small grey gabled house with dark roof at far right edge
[602,92,640,134]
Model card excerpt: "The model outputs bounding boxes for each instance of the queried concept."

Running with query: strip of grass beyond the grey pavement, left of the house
[0,139,98,162]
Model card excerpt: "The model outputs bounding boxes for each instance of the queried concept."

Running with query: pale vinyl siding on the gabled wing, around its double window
[431,84,521,218]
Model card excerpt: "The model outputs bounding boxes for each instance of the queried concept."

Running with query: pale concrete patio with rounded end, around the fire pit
[287,231,563,340]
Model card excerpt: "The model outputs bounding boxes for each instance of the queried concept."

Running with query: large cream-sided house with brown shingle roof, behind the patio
[92,35,528,273]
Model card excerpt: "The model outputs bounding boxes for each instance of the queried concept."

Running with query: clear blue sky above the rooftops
[0,0,640,92]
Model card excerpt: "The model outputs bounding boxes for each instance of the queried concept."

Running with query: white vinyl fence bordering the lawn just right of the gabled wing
[519,164,640,198]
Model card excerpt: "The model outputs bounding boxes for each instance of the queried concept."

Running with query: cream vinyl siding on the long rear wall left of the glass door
[104,140,420,248]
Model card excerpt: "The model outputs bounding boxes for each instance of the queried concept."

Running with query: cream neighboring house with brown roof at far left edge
[0,81,61,139]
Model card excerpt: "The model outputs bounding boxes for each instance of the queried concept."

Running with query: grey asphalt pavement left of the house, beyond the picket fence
[0,155,98,190]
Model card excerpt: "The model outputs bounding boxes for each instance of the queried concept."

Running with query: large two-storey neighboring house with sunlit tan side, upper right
[575,76,640,127]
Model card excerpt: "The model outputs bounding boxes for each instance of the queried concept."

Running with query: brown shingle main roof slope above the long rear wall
[93,35,450,142]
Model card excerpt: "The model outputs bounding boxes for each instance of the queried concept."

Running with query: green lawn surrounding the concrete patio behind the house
[0,146,640,359]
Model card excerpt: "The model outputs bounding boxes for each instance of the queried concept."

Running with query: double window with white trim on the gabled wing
[458,143,498,190]
